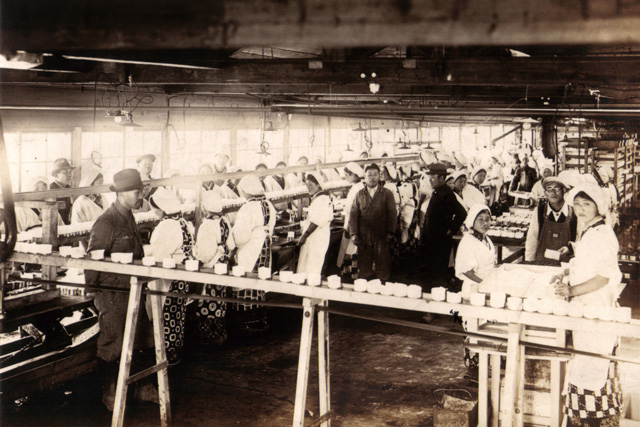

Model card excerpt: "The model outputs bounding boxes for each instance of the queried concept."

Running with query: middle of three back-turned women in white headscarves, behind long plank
[193,191,236,345]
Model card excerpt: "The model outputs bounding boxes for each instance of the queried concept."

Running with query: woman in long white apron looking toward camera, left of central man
[297,173,333,275]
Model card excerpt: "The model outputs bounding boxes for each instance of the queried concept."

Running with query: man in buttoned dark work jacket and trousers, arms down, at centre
[349,163,398,281]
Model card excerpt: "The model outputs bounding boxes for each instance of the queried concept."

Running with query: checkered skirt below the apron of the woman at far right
[564,361,622,425]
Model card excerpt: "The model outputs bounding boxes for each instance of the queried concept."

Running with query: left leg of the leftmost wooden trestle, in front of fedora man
[111,277,142,427]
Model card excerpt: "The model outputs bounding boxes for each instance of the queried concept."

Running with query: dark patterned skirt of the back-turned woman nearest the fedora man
[162,280,189,364]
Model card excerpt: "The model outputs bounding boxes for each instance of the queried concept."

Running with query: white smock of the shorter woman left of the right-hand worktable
[455,233,496,299]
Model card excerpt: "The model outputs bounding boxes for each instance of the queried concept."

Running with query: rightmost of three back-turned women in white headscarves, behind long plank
[233,175,276,333]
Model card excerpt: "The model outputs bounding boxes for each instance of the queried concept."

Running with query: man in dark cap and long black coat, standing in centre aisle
[422,163,467,291]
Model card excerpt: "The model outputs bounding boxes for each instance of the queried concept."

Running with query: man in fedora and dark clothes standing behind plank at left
[84,169,157,410]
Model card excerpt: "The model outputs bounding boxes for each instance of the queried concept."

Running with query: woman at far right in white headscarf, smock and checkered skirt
[554,183,622,426]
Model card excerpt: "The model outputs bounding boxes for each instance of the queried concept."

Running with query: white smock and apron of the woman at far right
[567,224,622,391]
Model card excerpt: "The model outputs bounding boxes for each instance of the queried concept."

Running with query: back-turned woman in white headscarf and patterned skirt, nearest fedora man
[149,188,194,364]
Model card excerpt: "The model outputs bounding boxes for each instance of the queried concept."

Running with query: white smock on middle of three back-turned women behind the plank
[193,217,236,268]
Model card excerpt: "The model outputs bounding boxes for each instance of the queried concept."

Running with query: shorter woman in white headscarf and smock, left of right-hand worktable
[455,203,496,371]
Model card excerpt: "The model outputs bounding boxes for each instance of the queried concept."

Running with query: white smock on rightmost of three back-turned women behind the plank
[233,199,276,272]
